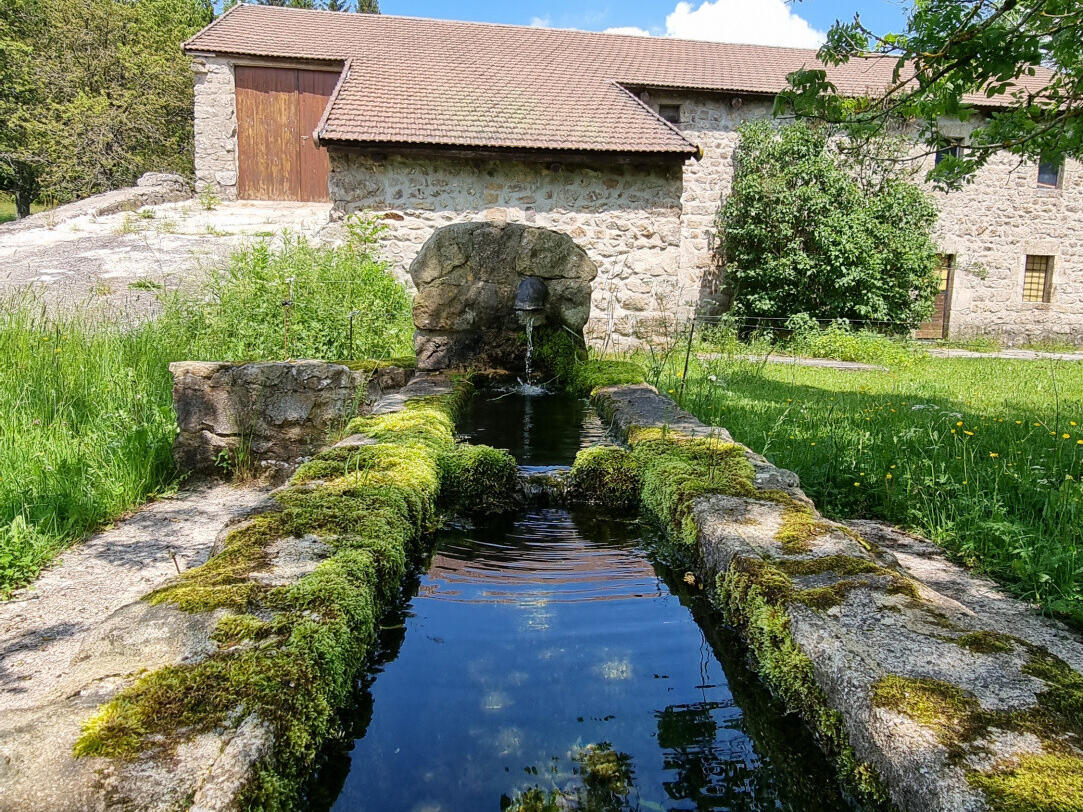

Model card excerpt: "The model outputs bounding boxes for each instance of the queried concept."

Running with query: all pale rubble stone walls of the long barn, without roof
[193,51,1083,348]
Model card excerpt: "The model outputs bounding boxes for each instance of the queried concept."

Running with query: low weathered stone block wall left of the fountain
[169,361,412,473]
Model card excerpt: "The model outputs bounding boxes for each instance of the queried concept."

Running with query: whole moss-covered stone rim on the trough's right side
[593,384,1083,812]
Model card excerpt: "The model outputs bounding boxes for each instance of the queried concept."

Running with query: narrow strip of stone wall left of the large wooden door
[192,56,237,200]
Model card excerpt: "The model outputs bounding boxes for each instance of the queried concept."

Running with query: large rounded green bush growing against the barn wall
[718,121,937,332]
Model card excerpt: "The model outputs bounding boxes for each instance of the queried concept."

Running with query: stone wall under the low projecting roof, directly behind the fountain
[330,149,680,348]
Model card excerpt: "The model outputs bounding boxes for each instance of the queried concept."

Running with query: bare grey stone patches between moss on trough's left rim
[0,376,444,812]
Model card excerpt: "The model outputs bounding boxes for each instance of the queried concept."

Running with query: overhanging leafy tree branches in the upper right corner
[778,0,1083,187]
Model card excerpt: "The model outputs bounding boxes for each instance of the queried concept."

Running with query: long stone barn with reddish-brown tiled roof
[185,5,1083,346]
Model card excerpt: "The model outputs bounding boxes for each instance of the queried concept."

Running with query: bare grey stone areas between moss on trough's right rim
[592,384,1083,812]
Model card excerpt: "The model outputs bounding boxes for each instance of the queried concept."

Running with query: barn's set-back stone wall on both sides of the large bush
[662,94,1083,343]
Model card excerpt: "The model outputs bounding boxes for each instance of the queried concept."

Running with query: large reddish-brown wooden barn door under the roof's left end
[234,65,338,200]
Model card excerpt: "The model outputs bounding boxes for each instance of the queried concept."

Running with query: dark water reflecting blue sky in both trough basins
[311,393,846,812]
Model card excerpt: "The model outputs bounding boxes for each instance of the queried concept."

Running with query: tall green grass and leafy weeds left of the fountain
[0,223,412,597]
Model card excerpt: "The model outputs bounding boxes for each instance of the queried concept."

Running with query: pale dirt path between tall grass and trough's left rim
[0,484,266,712]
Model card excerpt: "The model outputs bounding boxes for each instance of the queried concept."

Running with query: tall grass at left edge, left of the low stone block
[0,296,177,590]
